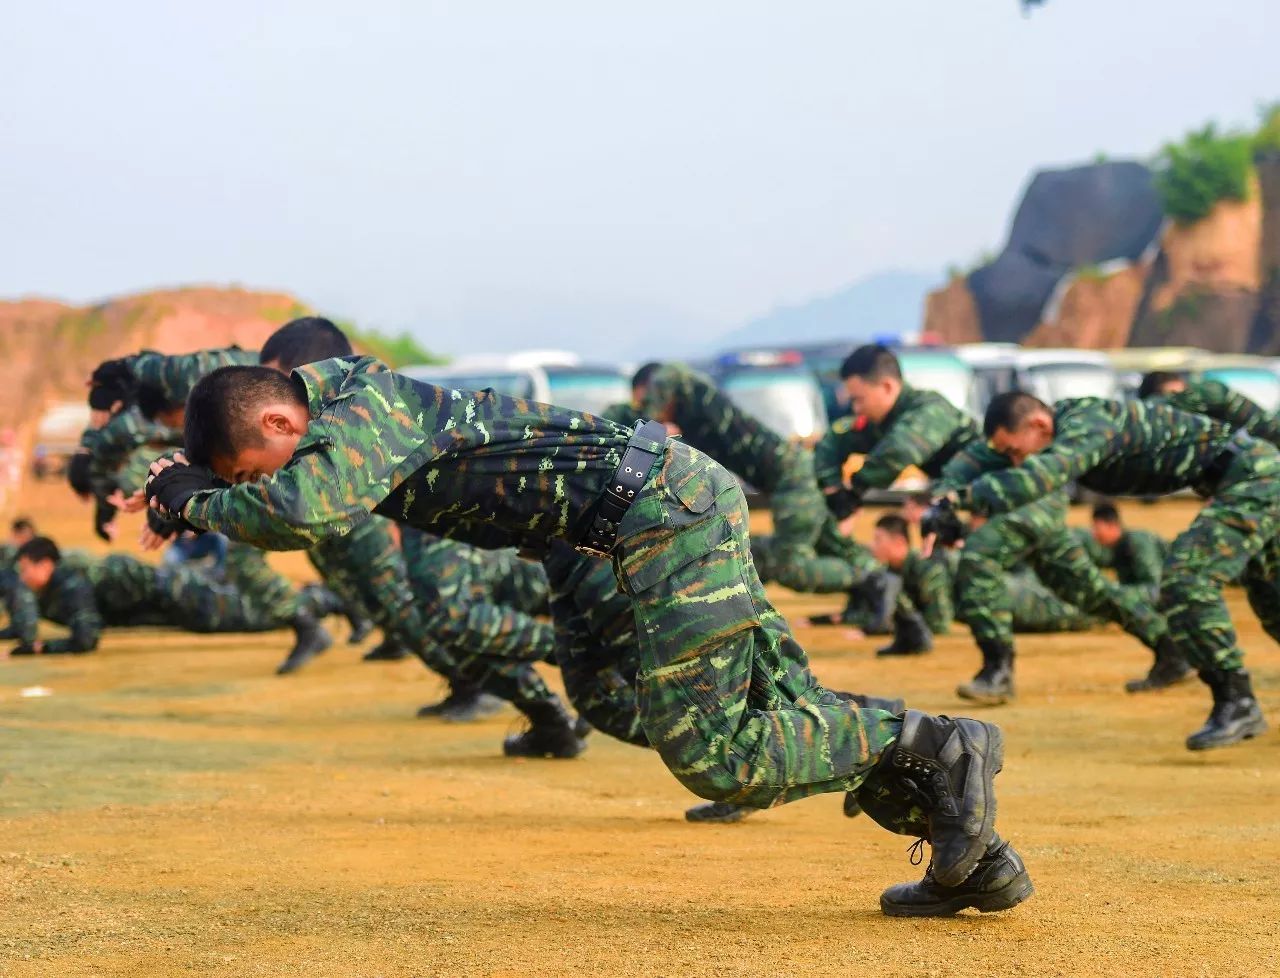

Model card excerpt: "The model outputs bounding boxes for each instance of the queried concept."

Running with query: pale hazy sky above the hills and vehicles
[0,0,1280,355]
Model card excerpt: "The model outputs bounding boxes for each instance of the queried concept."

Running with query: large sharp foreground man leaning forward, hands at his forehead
[147,358,1032,915]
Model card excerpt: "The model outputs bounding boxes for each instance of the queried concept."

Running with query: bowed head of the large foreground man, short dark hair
[183,366,311,483]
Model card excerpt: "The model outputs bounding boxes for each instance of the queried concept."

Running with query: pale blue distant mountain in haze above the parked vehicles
[716,271,942,349]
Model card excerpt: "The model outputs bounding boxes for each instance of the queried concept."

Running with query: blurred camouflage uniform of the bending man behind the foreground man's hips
[641,364,877,593]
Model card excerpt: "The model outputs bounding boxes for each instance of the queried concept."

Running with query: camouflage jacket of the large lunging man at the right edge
[963,397,1247,513]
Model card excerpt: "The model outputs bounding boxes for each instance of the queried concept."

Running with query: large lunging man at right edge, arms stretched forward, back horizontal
[960,393,1280,750]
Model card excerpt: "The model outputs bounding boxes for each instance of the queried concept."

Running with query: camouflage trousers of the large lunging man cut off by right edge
[1160,440,1280,671]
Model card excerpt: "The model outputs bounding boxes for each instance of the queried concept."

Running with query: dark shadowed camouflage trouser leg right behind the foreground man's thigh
[544,541,649,748]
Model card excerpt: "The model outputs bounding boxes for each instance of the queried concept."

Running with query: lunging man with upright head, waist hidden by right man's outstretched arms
[814,346,1174,704]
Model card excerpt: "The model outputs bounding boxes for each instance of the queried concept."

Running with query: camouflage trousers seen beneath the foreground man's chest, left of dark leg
[396,526,556,709]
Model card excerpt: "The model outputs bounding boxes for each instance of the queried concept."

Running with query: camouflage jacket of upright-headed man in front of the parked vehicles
[814,384,984,498]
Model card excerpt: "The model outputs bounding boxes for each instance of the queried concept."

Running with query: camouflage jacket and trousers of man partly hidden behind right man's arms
[814,384,1166,649]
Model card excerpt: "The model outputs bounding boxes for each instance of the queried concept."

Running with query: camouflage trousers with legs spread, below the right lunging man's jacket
[955,493,1167,649]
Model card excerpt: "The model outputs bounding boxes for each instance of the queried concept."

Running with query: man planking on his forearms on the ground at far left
[10,536,330,655]
